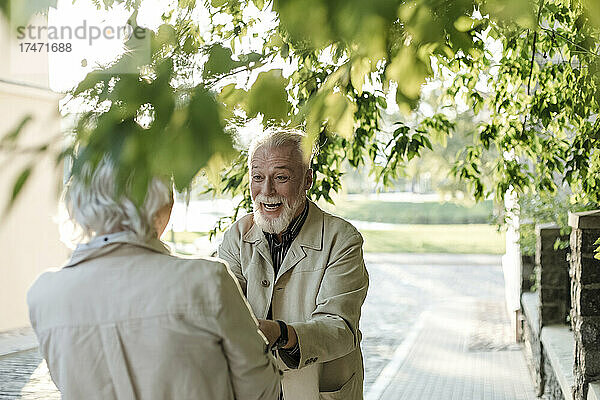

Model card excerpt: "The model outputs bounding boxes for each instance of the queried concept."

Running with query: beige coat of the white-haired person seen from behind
[28,233,280,400]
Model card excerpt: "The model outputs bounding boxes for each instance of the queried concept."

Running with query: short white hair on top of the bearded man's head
[248,127,315,170]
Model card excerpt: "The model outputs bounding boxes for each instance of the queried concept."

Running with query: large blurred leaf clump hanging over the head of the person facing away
[68,38,232,204]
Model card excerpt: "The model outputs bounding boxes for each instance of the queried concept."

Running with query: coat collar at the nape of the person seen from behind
[64,232,171,268]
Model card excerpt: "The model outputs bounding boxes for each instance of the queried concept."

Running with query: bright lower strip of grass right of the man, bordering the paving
[361,224,505,254]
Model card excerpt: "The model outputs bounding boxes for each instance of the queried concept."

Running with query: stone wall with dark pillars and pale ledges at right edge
[521,210,600,400]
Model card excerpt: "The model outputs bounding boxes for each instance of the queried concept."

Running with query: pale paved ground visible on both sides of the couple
[0,254,535,400]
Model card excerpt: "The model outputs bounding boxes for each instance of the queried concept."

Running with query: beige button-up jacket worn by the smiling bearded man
[219,202,369,400]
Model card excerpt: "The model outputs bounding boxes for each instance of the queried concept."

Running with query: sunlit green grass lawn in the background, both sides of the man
[163,200,505,254]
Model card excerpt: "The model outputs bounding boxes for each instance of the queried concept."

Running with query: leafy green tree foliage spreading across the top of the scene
[0,0,600,231]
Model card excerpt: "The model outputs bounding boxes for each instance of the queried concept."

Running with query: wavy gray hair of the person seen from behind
[64,159,173,241]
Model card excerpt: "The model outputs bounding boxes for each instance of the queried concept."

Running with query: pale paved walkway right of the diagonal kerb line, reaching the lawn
[365,255,537,400]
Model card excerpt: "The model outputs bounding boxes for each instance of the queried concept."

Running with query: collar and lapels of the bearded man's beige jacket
[242,200,323,250]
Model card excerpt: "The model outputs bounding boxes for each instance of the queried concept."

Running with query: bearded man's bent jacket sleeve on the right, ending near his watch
[286,232,369,368]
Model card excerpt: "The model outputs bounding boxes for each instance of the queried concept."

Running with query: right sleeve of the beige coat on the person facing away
[217,268,281,400]
